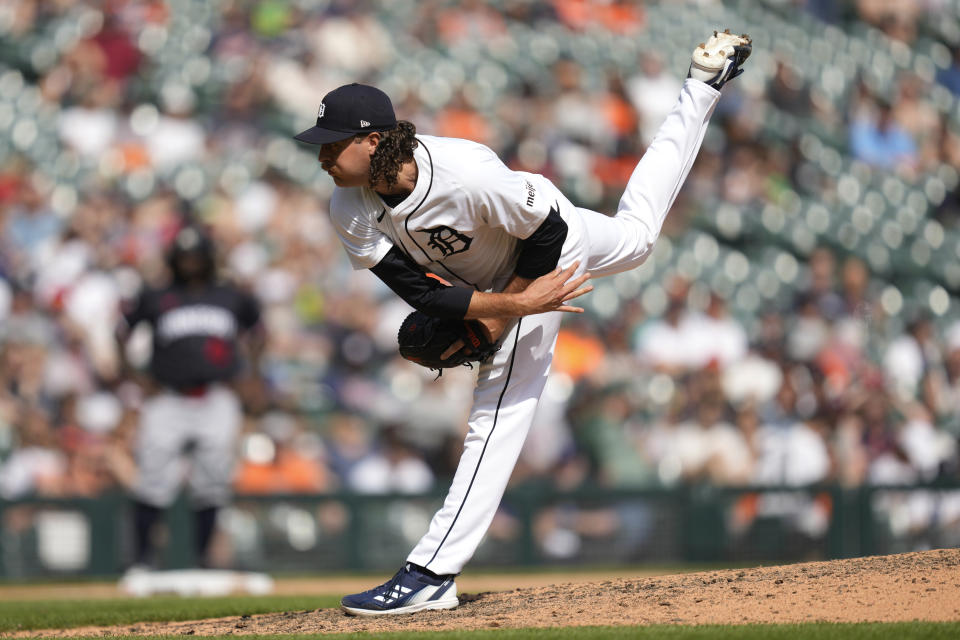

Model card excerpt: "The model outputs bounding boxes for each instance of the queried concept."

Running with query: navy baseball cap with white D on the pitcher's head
[294,82,397,144]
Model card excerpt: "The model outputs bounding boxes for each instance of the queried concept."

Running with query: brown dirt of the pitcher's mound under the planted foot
[11,549,960,637]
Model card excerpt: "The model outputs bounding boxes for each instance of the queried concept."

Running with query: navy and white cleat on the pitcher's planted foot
[340,563,460,616]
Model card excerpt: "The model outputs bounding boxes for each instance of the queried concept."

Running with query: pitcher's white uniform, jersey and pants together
[330,80,720,575]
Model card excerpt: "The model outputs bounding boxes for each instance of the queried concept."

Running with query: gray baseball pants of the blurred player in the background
[134,385,243,508]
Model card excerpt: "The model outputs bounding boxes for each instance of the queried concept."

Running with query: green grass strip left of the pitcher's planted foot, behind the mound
[0,595,340,633]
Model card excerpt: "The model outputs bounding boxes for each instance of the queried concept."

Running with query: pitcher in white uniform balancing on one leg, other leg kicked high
[296,32,751,615]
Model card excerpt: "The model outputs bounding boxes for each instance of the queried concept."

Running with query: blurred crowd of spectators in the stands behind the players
[0,0,960,524]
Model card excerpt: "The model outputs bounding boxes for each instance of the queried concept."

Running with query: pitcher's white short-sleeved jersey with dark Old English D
[330,136,557,291]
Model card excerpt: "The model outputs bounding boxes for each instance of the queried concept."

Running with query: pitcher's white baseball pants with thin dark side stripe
[407,80,720,574]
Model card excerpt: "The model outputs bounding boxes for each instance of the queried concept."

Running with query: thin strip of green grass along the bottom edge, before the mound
[28,622,960,640]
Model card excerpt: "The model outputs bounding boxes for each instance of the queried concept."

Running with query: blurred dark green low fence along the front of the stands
[0,482,960,580]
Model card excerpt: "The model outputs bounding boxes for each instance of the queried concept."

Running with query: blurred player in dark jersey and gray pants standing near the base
[117,226,263,568]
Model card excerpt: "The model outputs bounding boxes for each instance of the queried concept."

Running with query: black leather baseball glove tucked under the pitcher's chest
[397,311,500,372]
